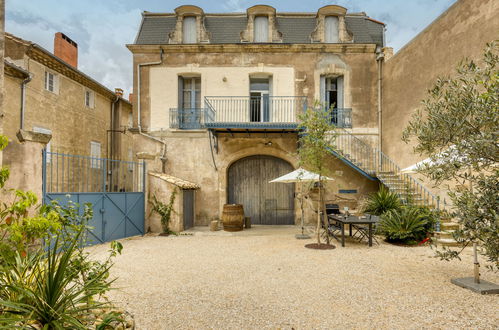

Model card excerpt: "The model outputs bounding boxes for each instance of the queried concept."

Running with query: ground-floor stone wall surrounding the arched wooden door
[149,131,378,229]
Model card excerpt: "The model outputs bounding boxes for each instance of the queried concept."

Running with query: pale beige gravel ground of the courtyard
[90,227,499,329]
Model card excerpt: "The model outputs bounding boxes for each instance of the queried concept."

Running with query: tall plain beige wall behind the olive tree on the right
[382,0,499,168]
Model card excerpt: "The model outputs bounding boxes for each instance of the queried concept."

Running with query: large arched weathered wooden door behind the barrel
[227,155,295,225]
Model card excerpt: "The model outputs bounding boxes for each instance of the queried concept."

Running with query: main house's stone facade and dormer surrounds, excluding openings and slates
[128,6,378,229]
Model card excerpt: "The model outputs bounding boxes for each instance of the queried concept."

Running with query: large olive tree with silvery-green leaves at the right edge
[403,42,499,275]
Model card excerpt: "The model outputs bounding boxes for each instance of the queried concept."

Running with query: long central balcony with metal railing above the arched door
[204,94,307,130]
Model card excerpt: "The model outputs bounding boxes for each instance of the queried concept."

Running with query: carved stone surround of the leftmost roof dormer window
[168,5,210,44]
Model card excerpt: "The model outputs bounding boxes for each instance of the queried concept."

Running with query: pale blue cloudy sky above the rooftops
[5,0,456,93]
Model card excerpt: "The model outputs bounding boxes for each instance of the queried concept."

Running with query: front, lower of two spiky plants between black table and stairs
[378,206,429,241]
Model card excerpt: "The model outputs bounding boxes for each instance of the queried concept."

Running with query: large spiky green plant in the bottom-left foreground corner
[0,227,112,329]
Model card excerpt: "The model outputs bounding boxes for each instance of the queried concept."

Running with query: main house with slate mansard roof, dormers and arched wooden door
[127,5,390,229]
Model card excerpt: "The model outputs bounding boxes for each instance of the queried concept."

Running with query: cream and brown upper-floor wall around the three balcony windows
[134,50,377,139]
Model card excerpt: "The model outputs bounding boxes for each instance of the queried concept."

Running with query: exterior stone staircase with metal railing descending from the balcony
[330,128,458,235]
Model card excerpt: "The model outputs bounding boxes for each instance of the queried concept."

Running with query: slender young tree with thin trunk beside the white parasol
[298,103,336,244]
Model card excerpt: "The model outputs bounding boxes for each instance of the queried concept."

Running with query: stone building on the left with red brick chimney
[2,33,135,196]
